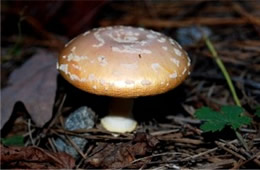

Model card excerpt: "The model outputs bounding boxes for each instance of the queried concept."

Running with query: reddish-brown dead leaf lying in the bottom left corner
[0,145,75,169]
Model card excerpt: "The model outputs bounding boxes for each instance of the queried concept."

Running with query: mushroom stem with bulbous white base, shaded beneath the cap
[101,98,137,133]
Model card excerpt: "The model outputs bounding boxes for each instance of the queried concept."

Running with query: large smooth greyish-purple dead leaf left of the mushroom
[1,50,58,129]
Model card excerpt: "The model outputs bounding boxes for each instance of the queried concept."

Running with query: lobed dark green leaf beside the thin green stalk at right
[195,106,251,132]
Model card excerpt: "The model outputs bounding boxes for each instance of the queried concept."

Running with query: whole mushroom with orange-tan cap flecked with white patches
[57,26,190,133]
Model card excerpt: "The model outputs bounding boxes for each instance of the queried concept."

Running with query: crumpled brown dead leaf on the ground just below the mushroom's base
[87,133,158,169]
